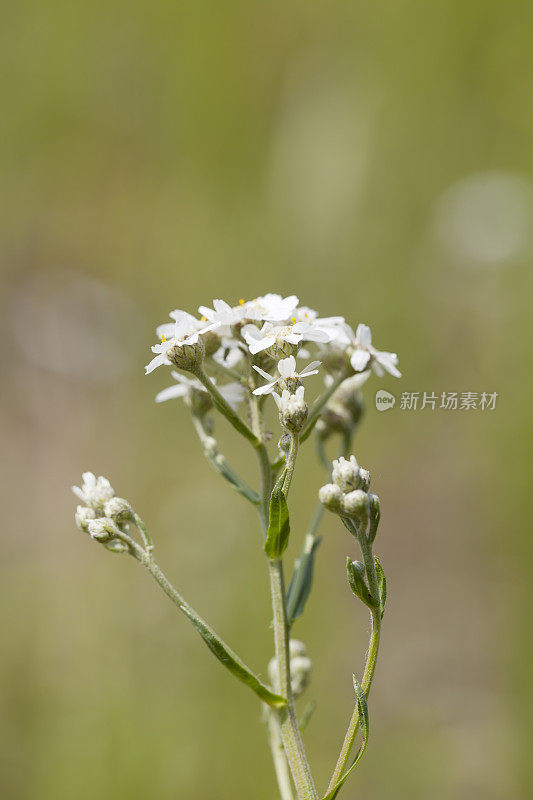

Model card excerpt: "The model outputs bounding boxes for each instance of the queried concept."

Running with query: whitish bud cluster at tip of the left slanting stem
[72,472,133,552]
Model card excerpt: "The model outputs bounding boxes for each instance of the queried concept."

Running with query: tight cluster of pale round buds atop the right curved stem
[318,456,380,538]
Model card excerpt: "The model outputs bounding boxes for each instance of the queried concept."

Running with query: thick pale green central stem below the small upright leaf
[269,560,318,800]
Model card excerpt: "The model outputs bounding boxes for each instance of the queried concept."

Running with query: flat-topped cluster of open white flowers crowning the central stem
[146,294,400,422]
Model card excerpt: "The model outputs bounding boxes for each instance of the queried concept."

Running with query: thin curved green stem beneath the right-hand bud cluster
[328,537,381,792]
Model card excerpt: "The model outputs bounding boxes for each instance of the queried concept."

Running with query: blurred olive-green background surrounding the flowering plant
[0,0,533,800]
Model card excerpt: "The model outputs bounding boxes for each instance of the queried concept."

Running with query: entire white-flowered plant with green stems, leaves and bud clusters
[69,294,400,800]
